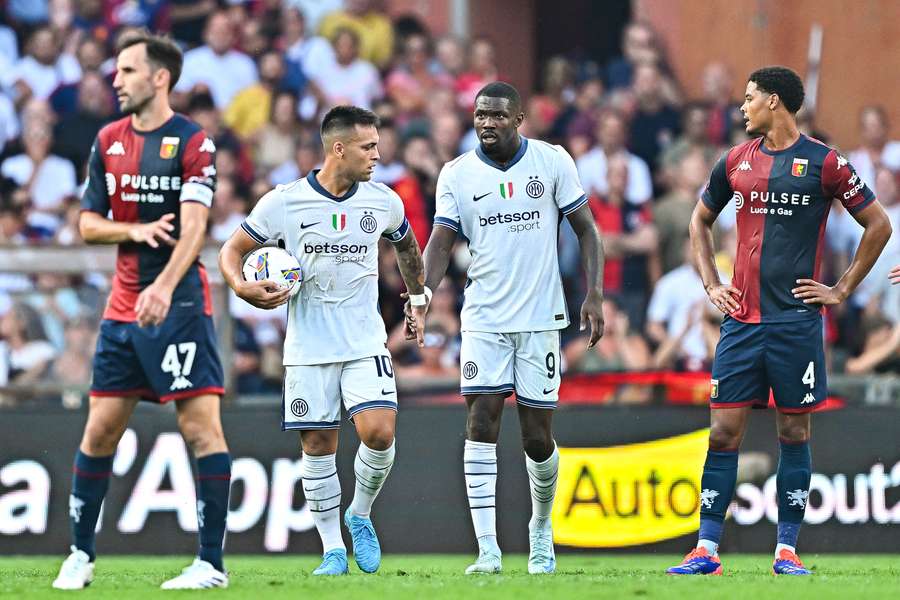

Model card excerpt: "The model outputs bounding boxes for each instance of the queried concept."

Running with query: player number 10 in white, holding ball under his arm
[219,106,428,575]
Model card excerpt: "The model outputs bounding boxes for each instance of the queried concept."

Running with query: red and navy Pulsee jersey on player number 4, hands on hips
[701,134,875,323]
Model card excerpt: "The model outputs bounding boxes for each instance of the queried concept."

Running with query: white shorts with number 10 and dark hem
[281,350,397,431]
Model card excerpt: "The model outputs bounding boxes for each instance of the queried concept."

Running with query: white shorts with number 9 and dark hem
[459,329,560,408]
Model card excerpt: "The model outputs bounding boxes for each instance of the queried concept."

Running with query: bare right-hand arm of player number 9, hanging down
[566,204,604,348]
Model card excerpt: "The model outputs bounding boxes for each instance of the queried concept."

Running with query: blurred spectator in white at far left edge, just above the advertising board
[0,303,57,392]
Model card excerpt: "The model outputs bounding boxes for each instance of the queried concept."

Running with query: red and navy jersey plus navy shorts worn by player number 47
[81,113,224,402]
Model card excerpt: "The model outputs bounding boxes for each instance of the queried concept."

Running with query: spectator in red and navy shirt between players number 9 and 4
[588,155,657,330]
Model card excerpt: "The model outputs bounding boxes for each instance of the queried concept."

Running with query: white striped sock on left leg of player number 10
[300,454,346,553]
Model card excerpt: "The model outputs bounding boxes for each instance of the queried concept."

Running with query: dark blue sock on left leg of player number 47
[69,450,113,562]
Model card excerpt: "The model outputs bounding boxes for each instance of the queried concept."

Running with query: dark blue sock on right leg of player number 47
[197,452,231,572]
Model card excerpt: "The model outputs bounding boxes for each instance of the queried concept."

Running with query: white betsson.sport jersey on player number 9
[434,137,587,333]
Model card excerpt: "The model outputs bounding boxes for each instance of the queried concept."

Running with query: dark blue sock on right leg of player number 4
[775,440,812,547]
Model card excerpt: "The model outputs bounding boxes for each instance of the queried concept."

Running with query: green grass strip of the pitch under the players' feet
[0,554,900,600]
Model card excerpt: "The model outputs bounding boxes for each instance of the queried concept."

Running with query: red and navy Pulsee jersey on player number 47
[81,114,216,322]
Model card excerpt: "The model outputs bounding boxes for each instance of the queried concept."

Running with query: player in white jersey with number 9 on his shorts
[407,82,603,573]
